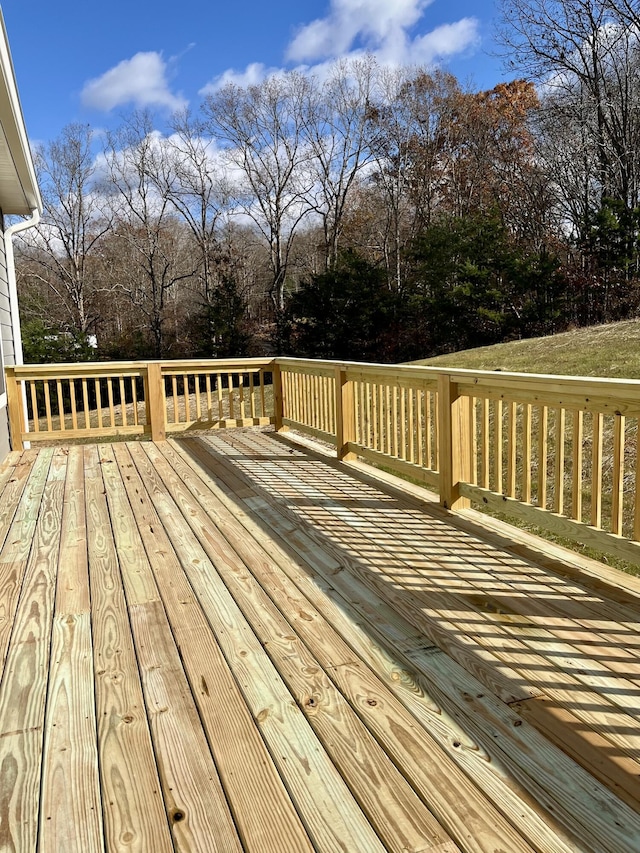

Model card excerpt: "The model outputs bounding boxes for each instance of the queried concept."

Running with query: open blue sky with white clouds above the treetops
[3,0,505,141]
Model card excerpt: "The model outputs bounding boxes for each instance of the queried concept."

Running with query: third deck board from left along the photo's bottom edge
[85,446,174,853]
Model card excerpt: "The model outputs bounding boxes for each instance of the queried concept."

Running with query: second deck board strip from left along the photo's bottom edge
[38,447,104,853]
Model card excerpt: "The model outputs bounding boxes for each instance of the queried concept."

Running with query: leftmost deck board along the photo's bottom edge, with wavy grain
[0,451,66,851]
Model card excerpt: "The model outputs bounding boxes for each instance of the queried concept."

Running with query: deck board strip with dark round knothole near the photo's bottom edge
[99,446,241,853]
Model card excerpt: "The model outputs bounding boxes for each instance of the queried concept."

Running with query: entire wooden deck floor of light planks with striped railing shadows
[0,430,640,853]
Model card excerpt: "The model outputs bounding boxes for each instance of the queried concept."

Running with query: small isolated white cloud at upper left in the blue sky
[81,51,187,112]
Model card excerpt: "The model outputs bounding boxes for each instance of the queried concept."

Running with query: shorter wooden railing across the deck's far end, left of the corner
[6,359,275,447]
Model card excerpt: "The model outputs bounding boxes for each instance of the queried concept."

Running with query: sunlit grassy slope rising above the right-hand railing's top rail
[413,320,640,379]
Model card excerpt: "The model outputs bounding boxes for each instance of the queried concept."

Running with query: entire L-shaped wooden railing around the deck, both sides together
[6,358,640,563]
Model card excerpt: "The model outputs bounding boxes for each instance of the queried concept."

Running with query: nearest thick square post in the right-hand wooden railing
[438,374,471,510]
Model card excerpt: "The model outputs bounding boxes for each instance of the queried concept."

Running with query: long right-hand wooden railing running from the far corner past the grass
[276,359,640,563]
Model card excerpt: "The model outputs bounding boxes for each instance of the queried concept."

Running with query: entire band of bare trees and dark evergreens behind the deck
[17,8,640,361]
